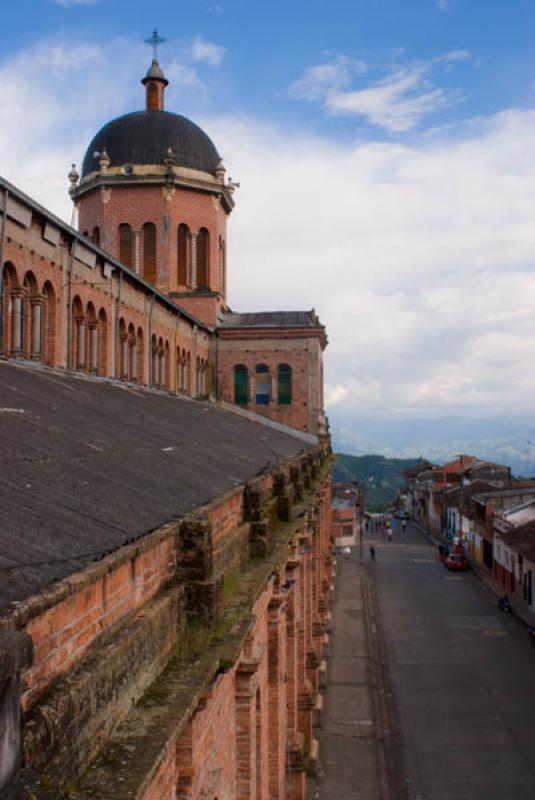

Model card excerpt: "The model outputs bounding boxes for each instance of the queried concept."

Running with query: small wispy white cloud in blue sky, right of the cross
[290,50,471,134]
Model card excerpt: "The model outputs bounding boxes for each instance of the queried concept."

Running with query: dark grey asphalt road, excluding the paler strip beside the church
[370,524,535,800]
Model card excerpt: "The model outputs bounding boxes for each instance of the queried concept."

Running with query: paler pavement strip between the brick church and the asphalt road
[309,554,406,800]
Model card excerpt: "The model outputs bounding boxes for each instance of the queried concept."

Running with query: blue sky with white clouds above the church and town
[0,0,535,460]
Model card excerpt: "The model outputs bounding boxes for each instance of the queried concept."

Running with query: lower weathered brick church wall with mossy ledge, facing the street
[0,448,333,800]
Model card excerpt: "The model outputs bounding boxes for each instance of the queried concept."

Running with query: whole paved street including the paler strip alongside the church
[316,525,535,800]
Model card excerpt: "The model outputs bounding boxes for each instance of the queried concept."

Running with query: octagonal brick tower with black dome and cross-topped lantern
[70,39,235,326]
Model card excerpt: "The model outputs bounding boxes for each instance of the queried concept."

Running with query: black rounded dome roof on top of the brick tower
[82,111,220,177]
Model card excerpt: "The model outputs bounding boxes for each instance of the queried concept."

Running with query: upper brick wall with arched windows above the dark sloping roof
[2,218,214,396]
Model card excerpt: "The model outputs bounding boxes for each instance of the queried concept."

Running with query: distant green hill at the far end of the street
[333,453,428,511]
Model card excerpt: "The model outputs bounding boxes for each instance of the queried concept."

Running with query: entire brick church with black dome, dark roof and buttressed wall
[0,51,334,800]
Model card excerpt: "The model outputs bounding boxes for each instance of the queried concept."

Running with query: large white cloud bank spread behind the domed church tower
[0,36,535,424]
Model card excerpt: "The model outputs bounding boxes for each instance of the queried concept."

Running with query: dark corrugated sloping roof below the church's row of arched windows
[0,361,315,607]
